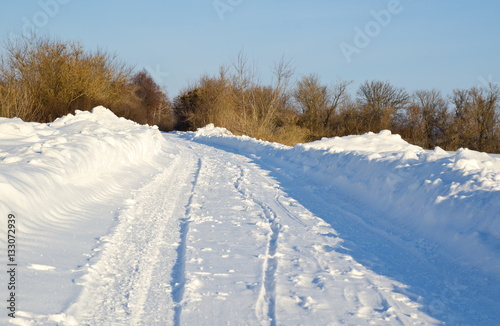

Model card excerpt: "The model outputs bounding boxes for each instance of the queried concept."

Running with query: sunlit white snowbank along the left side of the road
[0,107,165,318]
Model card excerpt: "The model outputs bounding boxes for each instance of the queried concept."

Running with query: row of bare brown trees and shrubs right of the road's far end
[173,55,500,153]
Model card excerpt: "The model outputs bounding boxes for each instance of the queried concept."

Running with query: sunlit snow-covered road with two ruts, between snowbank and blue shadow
[62,135,433,325]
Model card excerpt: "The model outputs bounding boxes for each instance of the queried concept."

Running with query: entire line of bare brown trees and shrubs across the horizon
[0,37,500,153]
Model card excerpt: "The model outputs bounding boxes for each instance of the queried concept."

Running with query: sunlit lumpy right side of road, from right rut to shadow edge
[217,148,436,325]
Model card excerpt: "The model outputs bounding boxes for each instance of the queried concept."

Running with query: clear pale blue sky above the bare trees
[0,0,500,97]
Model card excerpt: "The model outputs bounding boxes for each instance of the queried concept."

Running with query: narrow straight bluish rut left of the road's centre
[171,158,201,325]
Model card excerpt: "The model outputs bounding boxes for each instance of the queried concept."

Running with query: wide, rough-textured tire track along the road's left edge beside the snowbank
[67,151,199,325]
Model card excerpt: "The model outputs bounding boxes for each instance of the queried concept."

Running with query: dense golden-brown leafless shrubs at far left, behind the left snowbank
[0,36,131,122]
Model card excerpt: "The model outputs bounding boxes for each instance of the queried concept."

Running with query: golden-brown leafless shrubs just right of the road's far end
[174,54,306,144]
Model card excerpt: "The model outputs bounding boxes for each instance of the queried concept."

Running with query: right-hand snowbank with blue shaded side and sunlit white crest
[187,127,500,276]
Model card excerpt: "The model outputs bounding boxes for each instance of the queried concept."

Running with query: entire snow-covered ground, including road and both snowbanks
[0,111,500,325]
